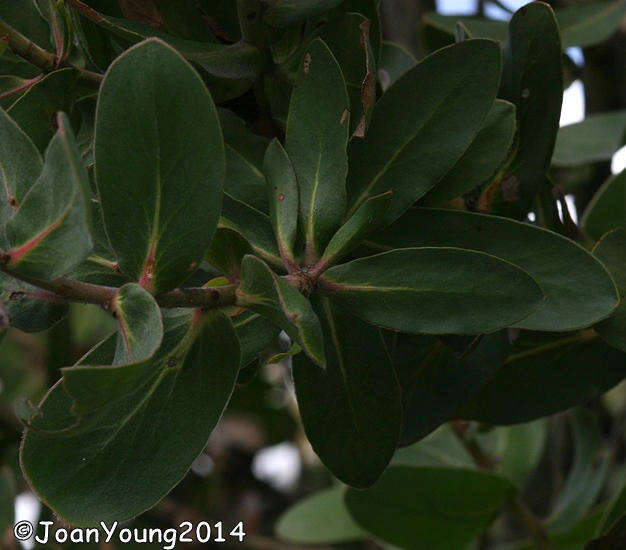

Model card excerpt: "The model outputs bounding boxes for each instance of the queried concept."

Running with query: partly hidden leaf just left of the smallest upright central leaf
[219,193,285,270]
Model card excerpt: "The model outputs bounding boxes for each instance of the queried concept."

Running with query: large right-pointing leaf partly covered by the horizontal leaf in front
[368,208,617,331]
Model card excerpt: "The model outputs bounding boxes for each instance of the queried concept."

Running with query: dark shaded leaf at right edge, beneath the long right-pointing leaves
[457,332,626,425]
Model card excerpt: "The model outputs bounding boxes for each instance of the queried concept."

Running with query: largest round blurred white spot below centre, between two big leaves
[252,442,302,491]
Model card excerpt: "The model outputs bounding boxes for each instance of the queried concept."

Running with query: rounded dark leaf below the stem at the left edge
[0,273,68,332]
